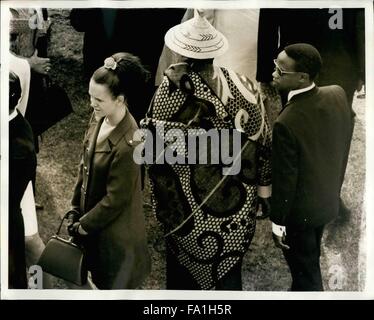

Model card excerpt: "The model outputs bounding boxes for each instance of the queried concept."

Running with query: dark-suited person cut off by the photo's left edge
[8,72,36,289]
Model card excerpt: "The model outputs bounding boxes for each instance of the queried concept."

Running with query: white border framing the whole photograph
[0,0,374,300]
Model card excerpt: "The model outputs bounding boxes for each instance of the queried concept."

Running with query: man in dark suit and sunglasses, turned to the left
[270,43,352,291]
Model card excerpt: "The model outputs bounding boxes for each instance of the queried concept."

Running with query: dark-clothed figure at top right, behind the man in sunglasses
[256,8,365,222]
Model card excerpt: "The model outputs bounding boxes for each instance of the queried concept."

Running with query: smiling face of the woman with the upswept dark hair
[88,79,118,118]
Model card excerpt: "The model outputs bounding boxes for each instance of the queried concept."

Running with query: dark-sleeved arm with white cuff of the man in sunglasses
[270,122,298,248]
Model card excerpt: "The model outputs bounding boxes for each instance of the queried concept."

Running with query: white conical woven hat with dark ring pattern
[165,10,229,59]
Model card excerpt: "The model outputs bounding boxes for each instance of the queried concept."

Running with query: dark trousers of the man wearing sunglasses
[283,226,324,291]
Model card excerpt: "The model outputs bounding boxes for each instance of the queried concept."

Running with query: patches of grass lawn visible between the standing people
[36,9,365,291]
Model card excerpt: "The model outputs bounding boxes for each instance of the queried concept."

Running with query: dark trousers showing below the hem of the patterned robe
[166,249,242,290]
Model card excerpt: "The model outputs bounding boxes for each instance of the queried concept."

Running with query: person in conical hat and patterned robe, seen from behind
[143,11,271,290]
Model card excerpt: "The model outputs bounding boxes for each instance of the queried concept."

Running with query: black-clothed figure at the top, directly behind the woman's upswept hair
[70,8,184,123]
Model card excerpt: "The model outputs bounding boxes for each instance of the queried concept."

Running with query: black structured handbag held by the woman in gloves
[38,215,87,286]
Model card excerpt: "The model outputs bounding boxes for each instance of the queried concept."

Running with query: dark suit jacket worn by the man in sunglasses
[271,86,351,227]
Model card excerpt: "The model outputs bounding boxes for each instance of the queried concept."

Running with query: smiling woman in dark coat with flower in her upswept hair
[68,53,150,289]
